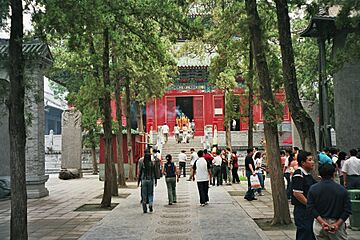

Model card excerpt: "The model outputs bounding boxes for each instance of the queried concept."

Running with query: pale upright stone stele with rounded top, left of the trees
[61,108,82,177]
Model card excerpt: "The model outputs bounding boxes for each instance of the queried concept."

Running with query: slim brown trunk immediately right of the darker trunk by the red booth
[115,80,127,188]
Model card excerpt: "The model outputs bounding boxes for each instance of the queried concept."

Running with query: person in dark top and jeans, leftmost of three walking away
[137,151,157,213]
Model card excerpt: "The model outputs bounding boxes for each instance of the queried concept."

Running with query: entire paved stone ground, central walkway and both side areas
[0,174,360,240]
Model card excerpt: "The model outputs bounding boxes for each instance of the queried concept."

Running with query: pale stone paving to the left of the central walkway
[0,174,114,240]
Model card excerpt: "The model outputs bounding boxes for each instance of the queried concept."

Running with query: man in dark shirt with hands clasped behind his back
[307,164,351,239]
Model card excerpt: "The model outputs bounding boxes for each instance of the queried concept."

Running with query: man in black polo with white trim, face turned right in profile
[291,151,316,240]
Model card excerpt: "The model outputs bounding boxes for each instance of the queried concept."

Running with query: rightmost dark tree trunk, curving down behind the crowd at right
[275,0,317,172]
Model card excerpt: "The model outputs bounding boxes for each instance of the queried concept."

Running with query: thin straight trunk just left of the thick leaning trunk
[246,44,254,148]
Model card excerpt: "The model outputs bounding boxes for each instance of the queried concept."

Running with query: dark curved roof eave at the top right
[300,16,337,38]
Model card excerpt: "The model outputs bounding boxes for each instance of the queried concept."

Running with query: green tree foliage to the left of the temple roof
[33,0,201,146]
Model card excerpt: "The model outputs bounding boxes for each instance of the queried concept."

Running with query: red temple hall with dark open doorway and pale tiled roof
[146,46,291,141]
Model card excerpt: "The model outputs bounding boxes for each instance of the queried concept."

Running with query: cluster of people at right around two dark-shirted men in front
[284,148,360,240]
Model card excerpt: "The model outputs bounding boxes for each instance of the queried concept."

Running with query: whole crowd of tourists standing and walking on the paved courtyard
[138,140,360,240]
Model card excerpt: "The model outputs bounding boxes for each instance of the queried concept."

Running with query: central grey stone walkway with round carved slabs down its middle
[80,178,268,240]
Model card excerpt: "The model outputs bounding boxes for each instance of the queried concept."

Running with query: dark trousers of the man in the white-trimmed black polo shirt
[294,205,315,240]
